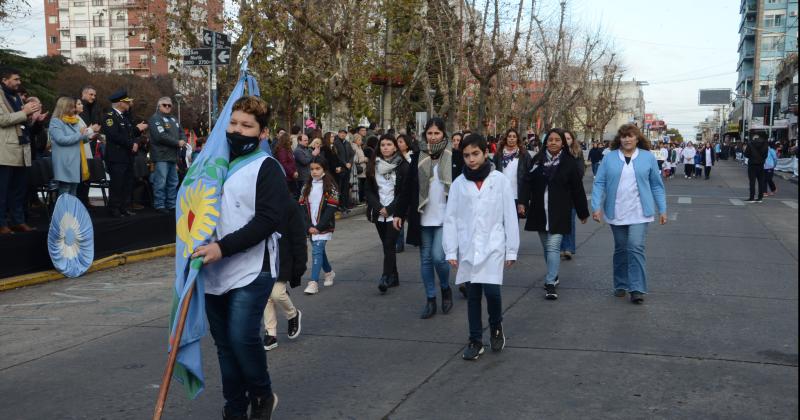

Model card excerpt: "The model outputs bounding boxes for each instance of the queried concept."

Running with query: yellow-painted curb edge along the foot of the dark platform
[0,244,175,292]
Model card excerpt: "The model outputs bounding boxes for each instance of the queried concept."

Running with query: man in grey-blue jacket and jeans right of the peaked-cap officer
[148,96,186,213]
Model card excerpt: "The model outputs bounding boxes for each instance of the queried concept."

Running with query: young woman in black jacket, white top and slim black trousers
[365,134,408,293]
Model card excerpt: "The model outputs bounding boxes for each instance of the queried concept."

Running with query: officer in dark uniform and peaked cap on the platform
[102,89,147,217]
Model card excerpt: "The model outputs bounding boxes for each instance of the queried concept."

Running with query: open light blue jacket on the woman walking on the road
[592,149,667,219]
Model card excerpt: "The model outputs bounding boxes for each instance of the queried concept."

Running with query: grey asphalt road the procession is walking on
[0,162,798,420]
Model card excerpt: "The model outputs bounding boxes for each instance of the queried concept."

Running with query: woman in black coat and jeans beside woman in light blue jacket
[517,128,589,300]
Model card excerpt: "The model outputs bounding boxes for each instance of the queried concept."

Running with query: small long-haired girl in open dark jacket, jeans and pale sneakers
[300,156,339,295]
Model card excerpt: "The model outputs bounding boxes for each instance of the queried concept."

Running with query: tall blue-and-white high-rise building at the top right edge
[728,0,797,138]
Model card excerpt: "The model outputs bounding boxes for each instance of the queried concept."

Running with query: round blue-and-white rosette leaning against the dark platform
[47,194,94,277]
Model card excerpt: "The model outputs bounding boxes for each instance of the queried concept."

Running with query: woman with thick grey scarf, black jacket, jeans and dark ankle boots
[393,117,457,319]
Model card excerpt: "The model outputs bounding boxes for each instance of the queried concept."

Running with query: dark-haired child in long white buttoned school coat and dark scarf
[442,134,519,360]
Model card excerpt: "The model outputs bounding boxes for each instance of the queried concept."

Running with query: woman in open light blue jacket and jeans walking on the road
[592,124,667,304]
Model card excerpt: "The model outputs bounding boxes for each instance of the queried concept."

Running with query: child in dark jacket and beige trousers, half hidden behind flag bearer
[264,196,308,351]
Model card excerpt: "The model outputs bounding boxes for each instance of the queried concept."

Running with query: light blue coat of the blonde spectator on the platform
[48,118,90,183]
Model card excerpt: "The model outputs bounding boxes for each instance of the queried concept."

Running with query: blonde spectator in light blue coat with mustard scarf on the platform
[48,96,90,195]
